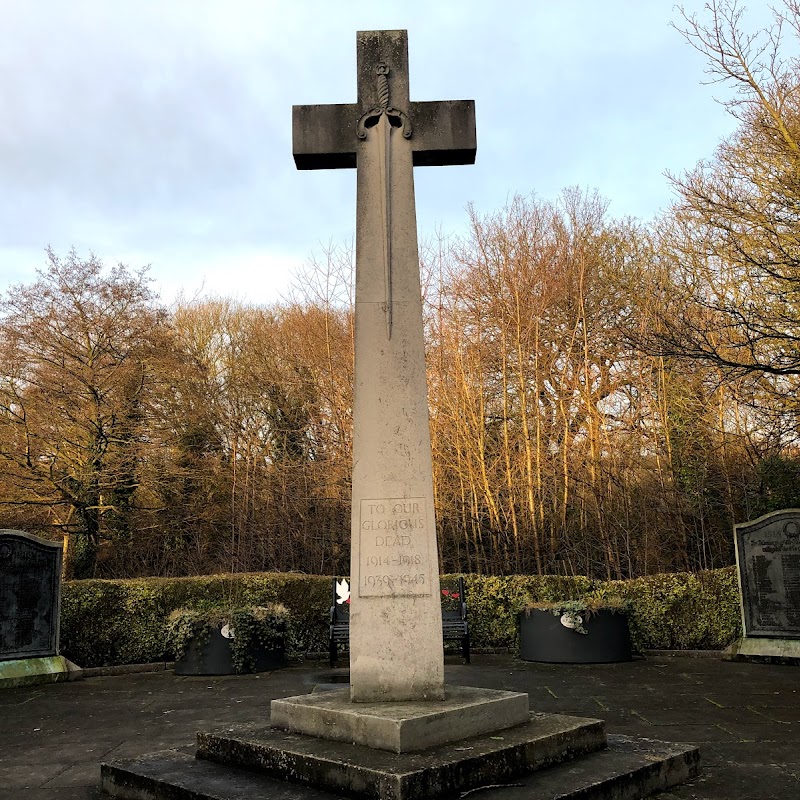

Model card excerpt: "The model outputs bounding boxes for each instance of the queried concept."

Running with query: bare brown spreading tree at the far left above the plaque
[0,251,167,577]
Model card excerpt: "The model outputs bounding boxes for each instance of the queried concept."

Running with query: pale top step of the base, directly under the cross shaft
[270,686,530,753]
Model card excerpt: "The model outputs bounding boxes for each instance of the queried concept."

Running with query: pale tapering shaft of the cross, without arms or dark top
[350,40,444,701]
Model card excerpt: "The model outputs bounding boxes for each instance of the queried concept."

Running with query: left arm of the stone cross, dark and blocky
[292,103,358,169]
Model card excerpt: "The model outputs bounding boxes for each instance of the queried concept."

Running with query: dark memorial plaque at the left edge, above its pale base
[0,530,61,661]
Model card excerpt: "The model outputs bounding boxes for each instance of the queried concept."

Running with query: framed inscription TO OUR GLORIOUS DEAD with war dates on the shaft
[358,497,431,597]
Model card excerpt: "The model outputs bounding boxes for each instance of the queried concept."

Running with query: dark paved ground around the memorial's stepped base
[0,655,800,800]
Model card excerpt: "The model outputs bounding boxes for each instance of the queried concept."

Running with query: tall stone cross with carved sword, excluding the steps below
[292,31,476,702]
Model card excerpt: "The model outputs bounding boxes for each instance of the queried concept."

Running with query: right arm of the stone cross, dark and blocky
[409,100,478,167]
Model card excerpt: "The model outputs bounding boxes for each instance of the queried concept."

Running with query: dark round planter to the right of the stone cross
[519,608,632,664]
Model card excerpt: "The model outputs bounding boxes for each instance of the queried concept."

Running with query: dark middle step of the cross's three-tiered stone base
[197,714,606,800]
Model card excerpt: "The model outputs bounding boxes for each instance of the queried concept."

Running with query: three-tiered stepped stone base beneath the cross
[97,686,699,800]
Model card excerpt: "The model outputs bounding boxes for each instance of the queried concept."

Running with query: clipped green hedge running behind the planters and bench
[61,567,740,667]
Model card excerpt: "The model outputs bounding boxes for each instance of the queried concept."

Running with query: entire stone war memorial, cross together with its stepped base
[103,31,697,800]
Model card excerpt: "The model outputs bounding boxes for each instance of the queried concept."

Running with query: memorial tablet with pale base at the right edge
[732,509,800,658]
